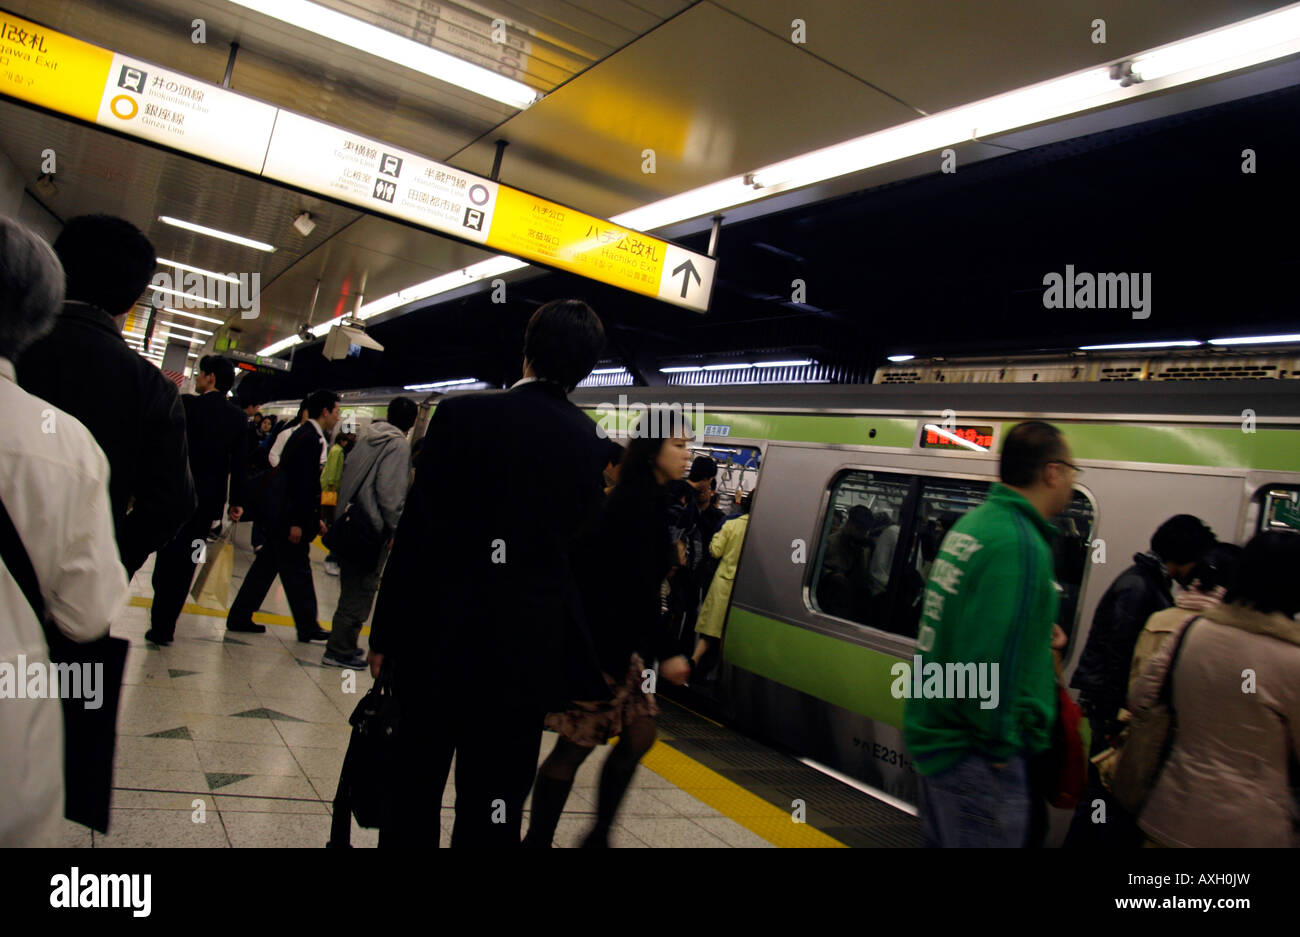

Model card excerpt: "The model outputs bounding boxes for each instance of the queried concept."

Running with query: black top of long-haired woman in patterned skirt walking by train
[577,486,677,682]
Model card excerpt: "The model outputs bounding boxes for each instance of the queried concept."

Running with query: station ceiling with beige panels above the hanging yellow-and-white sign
[0,0,1294,379]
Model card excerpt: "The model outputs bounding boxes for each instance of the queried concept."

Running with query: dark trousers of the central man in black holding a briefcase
[380,678,546,850]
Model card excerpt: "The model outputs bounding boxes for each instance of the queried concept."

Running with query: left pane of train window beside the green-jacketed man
[811,470,913,630]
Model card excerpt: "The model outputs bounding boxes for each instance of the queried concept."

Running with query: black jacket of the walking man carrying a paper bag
[181,391,248,521]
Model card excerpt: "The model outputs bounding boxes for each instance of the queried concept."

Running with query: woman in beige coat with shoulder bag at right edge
[1128,533,1300,846]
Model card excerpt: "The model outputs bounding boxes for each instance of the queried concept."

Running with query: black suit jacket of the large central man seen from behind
[371,381,608,707]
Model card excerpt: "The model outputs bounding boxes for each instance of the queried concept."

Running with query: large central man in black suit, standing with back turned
[371,300,610,847]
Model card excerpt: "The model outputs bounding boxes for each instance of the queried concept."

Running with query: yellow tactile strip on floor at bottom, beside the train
[641,742,848,849]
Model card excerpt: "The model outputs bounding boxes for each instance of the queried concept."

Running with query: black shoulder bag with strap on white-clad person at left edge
[0,493,130,833]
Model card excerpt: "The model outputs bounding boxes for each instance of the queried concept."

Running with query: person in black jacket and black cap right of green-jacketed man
[1065,515,1216,849]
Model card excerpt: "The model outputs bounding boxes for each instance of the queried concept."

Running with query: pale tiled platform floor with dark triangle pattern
[62,524,771,847]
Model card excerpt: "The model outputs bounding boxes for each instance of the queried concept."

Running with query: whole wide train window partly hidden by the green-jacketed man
[811,472,1096,638]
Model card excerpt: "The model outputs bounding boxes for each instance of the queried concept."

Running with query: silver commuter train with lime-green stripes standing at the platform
[264,381,1300,823]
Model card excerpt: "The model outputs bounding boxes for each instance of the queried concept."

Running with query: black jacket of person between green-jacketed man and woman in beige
[1070,554,1174,721]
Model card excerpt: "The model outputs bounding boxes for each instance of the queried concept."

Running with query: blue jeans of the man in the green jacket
[920,754,1030,849]
